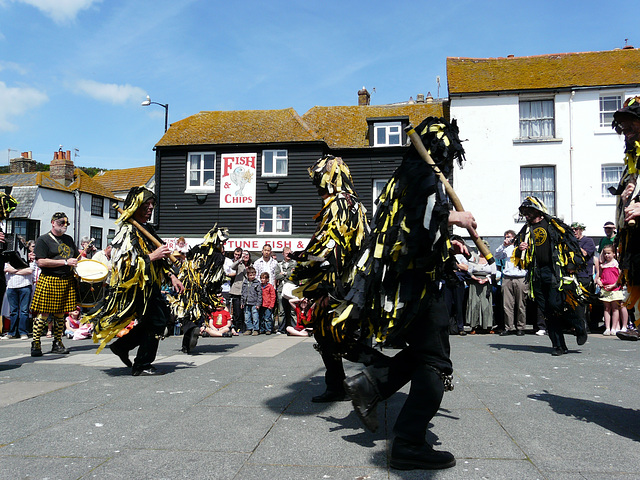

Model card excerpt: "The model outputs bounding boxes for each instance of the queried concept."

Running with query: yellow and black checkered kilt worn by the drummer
[31,275,79,314]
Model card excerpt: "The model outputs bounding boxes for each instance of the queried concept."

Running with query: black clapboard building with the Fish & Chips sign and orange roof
[155,98,448,252]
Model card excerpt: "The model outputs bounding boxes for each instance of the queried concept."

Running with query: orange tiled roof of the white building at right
[447,48,640,95]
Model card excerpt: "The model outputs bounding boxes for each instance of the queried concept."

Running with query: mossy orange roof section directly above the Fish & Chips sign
[156,108,317,147]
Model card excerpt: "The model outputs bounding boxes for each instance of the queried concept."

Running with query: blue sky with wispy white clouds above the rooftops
[0,0,640,169]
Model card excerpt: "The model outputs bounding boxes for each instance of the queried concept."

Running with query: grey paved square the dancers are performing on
[0,332,640,480]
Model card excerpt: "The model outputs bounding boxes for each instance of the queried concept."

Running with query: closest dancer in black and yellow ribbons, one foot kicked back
[340,117,477,470]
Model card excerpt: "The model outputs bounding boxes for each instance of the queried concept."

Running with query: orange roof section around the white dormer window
[302,101,445,148]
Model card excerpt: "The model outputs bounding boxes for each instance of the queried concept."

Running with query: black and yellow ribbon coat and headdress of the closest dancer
[332,117,464,343]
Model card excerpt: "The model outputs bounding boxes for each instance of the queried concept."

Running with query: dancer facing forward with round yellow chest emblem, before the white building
[511,196,587,356]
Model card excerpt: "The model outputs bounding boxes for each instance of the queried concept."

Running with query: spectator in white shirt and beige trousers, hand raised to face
[496,230,528,336]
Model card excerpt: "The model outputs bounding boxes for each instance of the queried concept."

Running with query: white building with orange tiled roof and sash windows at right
[447,48,640,247]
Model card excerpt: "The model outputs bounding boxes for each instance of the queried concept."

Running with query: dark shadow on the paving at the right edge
[529,391,640,442]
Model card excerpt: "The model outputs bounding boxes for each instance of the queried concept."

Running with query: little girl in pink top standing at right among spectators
[596,245,628,336]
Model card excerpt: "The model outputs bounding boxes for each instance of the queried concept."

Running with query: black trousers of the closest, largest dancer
[365,285,453,444]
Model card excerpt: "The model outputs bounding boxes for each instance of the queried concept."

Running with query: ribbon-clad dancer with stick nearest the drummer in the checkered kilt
[83,186,184,376]
